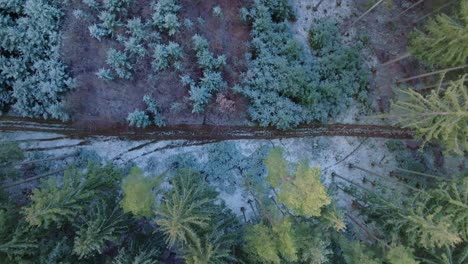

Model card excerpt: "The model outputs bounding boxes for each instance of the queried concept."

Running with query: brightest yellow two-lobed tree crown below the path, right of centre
[265,148,331,217]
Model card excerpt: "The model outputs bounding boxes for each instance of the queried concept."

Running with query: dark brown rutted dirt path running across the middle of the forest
[0,117,413,140]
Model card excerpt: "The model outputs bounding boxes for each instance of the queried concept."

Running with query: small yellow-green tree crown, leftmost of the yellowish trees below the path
[120,167,161,217]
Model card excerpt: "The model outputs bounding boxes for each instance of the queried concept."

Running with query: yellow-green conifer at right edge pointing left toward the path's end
[384,75,468,155]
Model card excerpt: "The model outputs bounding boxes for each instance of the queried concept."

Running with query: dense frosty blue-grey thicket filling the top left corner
[0,0,75,121]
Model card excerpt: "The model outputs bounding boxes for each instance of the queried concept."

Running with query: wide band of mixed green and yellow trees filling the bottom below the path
[0,142,468,264]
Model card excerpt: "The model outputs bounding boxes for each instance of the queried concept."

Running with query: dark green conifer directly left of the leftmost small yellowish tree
[24,164,120,228]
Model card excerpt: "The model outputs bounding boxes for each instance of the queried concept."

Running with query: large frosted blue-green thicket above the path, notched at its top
[235,1,366,129]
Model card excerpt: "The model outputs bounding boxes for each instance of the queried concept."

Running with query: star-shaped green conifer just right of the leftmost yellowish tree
[155,169,216,247]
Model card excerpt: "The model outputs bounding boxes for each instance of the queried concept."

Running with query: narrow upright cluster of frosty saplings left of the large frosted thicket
[181,35,227,113]
